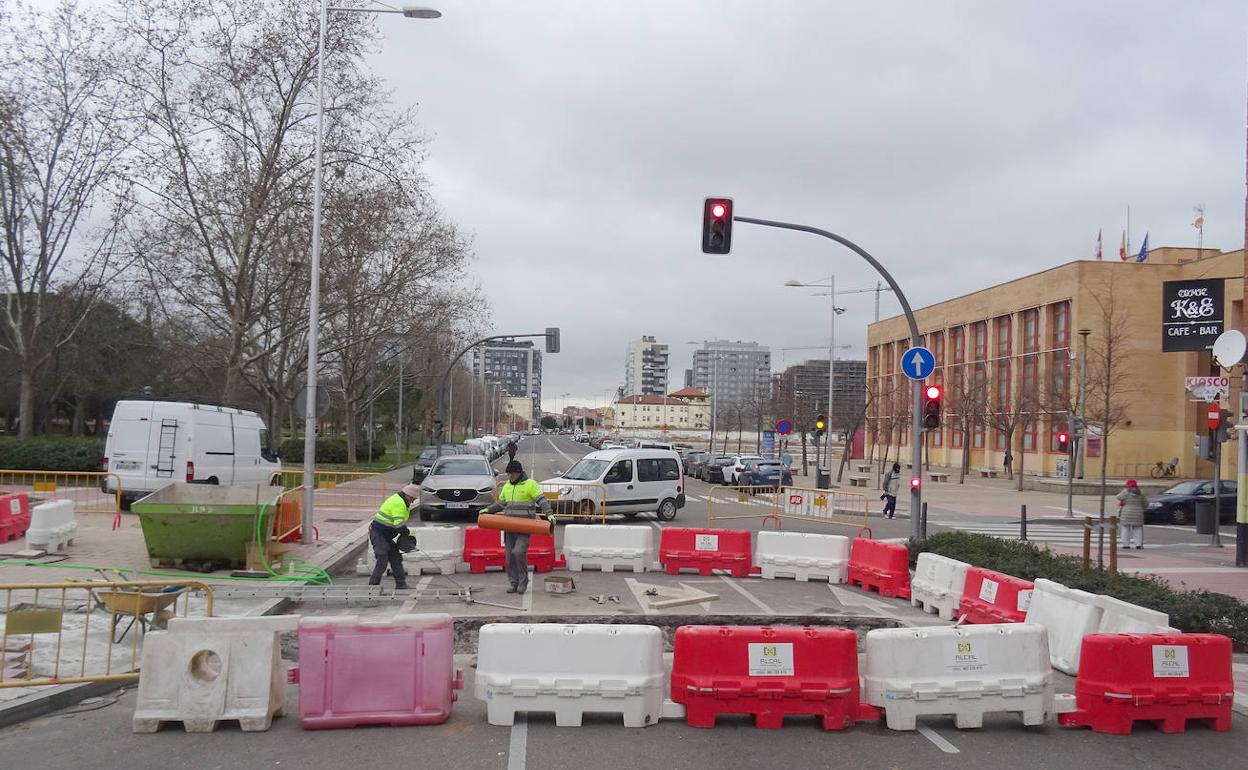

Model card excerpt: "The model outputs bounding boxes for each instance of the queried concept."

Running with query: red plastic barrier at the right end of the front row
[1057,634,1236,735]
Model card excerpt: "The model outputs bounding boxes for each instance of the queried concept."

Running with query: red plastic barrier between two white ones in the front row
[671,625,880,730]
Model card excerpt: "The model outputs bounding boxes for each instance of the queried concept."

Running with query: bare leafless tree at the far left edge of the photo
[0,0,127,438]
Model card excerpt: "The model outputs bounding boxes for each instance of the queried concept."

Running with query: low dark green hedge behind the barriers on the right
[910,532,1248,651]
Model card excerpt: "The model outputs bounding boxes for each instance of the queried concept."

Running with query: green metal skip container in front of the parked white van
[131,483,282,569]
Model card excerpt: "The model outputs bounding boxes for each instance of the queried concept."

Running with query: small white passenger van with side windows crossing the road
[542,449,685,522]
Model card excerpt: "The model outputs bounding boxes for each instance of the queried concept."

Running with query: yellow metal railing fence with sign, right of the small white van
[706,487,867,530]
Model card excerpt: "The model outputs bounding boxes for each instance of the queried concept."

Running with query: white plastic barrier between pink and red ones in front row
[474,623,665,728]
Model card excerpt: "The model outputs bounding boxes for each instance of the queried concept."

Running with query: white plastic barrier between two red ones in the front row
[862,623,1055,730]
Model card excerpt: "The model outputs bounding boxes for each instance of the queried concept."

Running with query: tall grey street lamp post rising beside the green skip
[300,0,442,544]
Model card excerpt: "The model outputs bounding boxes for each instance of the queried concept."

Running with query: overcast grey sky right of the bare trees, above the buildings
[371,0,1248,408]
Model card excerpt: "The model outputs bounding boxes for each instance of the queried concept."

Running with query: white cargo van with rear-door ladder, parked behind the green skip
[104,401,282,509]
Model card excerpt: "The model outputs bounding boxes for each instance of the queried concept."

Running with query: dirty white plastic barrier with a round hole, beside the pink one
[131,618,286,733]
